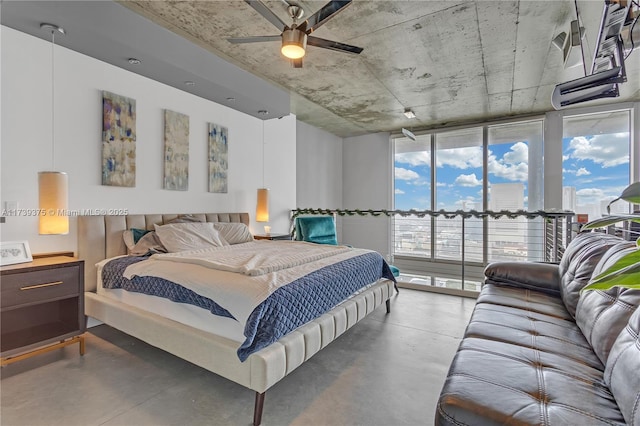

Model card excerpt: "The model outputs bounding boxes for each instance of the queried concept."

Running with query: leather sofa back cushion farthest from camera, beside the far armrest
[559,232,620,318]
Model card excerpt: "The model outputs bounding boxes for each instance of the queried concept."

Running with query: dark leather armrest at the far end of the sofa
[484,262,560,295]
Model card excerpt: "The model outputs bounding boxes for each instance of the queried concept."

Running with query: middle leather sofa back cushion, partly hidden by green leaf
[576,242,640,364]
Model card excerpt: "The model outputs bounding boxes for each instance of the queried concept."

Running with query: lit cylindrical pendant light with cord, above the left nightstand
[38,24,69,235]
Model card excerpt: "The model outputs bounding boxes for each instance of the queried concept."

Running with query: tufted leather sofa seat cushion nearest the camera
[436,337,625,426]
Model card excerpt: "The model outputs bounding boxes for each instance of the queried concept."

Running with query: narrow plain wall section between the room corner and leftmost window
[342,133,392,257]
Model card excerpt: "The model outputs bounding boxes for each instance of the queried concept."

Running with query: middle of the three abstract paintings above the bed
[164,109,189,191]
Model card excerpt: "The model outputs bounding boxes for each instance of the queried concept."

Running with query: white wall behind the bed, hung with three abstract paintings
[0,26,296,252]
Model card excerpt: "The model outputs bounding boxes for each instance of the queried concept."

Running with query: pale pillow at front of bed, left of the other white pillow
[154,222,229,253]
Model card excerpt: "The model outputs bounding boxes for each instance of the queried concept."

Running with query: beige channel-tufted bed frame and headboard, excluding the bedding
[78,213,395,425]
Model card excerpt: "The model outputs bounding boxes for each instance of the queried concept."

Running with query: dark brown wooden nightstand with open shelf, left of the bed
[0,253,86,366]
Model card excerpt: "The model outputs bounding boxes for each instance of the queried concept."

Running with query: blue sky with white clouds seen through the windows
[395,133,629,210]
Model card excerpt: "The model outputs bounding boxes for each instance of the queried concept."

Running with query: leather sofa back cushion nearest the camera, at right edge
[604,308,640,425]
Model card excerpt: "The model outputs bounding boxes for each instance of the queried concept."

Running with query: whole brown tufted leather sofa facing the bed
[435,233,640,426]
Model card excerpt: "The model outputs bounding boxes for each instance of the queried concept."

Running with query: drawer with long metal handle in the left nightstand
[0,266,80,308]
